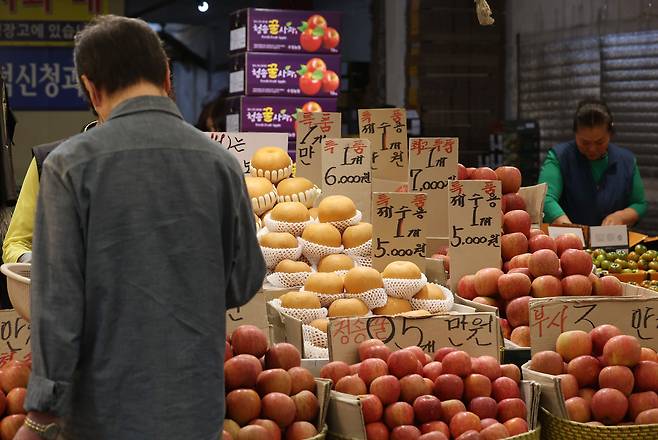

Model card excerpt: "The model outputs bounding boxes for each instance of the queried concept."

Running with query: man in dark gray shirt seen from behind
[16,16,264,440]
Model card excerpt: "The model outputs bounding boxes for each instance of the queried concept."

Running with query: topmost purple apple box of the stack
[229,8,340,53]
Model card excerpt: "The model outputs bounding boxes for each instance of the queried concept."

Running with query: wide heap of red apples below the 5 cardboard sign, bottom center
[320,339,528,440]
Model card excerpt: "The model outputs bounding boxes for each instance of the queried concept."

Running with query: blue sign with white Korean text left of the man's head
[0,47,89,110]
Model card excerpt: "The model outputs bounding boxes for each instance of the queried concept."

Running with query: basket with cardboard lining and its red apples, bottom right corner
[522,324,658,439]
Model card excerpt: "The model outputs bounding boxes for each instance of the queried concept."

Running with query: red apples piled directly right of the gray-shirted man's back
[223,325,320,440]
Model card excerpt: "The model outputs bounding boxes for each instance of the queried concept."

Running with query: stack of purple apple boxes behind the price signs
[226,8,341,157]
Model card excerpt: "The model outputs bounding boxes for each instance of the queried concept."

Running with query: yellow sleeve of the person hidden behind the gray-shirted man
[2,159,39,263]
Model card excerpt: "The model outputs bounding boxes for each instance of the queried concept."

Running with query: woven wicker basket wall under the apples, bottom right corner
[540,408,658,440]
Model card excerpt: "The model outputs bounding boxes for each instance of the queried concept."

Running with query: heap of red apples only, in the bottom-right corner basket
[531,324,658,425]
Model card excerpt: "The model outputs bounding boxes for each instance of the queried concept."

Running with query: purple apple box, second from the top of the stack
[228,52,340,98]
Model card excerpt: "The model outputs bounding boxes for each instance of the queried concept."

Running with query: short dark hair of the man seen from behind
[73,15,167,98]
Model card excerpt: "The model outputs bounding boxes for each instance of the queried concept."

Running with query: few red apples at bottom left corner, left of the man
[0,361,31,440]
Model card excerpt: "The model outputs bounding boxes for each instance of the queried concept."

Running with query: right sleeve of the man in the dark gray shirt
[226,170,265,309]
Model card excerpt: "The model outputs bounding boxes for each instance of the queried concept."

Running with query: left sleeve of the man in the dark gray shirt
[25,161,85,417]
